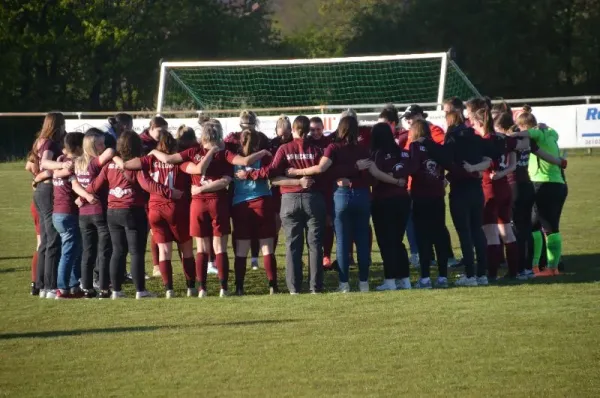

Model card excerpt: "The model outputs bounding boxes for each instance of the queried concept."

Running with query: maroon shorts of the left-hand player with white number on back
[148,203,191,243]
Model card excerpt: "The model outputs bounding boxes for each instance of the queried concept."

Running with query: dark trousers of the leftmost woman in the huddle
[33,184,61,290]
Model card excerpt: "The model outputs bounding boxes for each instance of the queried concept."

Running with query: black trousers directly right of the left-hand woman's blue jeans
[79,214,112,290]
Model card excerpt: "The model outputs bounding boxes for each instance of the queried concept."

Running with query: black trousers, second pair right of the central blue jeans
[413,196,449,278]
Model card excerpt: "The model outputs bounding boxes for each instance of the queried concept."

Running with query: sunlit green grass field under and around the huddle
[0,157,600,397]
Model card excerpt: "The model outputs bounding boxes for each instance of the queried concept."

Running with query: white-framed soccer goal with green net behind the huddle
[157,53,479,114]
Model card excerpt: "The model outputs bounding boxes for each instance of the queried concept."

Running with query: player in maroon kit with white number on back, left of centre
[115,129,198,299]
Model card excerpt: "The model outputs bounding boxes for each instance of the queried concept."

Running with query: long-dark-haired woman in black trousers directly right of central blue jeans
[358,123,411,291]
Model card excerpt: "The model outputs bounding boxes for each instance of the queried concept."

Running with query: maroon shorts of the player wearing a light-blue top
[231,196,276,240]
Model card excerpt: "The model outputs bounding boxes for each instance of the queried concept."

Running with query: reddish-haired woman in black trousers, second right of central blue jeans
[409,120,449,289]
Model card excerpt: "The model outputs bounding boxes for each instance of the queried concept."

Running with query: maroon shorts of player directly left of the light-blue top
[189,197,231,238]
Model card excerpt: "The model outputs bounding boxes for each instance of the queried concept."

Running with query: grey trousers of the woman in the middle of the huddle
[280,192,325,293]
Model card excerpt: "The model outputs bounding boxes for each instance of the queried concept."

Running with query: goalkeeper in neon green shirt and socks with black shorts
[515,106,567,276]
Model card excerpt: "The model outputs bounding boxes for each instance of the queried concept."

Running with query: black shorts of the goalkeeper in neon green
[531,182,567,235]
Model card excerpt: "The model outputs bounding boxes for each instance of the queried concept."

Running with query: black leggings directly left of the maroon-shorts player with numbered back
[107,207,148,292]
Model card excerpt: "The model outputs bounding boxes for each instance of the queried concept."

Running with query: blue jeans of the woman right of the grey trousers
[333,187,371,282]
